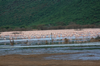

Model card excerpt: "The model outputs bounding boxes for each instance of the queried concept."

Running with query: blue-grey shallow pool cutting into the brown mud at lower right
[45,50,100,60]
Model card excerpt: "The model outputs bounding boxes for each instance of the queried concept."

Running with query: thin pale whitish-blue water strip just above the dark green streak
[0,42,100,48]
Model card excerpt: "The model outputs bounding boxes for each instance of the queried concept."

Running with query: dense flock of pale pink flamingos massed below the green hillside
[0,29,100,44]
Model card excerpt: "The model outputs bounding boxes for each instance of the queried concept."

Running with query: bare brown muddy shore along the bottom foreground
[0,53,100,66]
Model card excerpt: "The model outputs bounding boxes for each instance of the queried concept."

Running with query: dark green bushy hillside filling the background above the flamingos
[0,0,100,29]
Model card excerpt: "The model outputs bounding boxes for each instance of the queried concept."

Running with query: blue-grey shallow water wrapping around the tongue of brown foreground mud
[0,42,100,60]
